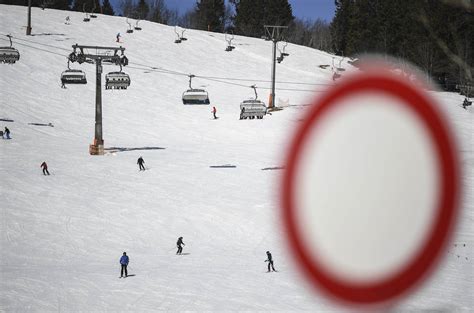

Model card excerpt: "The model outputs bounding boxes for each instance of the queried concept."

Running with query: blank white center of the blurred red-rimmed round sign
[294,92,440,282]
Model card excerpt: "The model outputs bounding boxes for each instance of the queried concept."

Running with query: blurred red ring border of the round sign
[281,72,460,305]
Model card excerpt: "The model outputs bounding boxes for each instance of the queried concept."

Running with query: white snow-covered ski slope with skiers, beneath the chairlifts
[0,5,474,312]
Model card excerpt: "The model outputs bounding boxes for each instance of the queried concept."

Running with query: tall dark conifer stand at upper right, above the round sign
[331,0,474,90]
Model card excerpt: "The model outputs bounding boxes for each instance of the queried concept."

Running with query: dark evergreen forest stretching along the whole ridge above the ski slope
[0,0,474,91]
